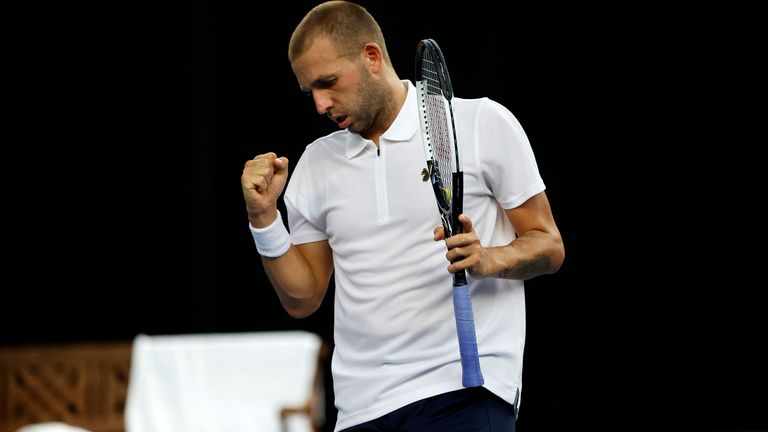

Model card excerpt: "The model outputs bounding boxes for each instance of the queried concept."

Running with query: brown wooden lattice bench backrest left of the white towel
[0,341,131,432]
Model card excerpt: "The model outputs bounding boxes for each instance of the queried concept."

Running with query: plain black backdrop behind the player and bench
[0,0,768,431]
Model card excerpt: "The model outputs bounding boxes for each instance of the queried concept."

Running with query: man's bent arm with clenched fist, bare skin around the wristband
[240,153,333,318]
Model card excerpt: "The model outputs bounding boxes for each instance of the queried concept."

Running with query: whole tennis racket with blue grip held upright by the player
[416,39,484,387]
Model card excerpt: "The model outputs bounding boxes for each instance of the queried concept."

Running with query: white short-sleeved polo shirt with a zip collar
[285,81,544,430]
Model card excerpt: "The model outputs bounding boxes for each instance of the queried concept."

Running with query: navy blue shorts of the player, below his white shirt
[343,387,515,432]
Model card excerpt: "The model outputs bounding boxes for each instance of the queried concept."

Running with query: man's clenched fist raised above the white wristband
[240,152,288,228]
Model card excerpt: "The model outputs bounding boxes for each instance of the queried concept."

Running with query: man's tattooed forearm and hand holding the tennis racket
[435,192,565,279]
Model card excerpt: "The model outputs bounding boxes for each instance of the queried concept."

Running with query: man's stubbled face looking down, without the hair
[291,37,389,136]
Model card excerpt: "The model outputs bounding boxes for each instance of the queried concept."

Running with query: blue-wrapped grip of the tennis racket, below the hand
[453,284,485,387]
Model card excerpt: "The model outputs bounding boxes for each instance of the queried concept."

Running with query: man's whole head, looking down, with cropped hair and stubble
[288,1,405,140]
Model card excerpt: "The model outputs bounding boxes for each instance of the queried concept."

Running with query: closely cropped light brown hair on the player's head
[288,1,392,64]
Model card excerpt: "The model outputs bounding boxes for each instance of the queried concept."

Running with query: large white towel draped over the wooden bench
[125,331,321,432]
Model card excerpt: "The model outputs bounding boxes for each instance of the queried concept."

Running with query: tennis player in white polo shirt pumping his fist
[241,1,565,432]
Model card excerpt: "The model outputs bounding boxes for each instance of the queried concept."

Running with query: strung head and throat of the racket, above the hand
[416,39,461,237]
